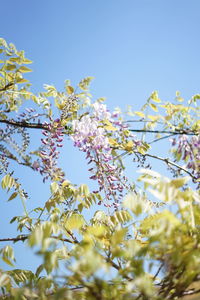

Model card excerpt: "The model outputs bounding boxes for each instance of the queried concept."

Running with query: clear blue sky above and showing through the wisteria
[0,0,200,268]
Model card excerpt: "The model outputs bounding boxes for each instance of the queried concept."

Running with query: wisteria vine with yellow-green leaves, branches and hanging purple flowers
[0,39,200,300]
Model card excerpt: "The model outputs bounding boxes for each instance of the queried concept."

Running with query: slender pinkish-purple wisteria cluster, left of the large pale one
[33,119,64,182]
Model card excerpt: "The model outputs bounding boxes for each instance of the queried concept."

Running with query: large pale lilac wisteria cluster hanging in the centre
[71,102,137,208]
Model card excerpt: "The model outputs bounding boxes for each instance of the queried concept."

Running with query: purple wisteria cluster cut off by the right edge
[172,135,200,179]
